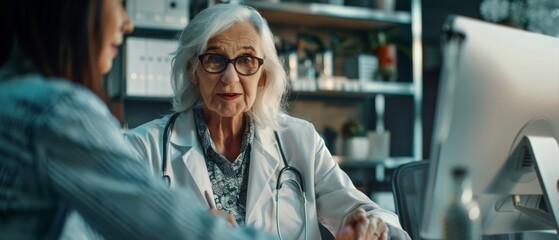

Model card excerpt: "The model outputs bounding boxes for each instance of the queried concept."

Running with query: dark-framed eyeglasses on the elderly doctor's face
[198,53,264,76]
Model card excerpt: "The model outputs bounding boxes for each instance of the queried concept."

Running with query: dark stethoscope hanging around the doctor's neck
[161,112,307,240]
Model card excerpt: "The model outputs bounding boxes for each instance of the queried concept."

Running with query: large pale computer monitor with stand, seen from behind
[420,16,559,239]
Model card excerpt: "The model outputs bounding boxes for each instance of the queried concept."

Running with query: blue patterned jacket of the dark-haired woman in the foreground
[0,53,272,239]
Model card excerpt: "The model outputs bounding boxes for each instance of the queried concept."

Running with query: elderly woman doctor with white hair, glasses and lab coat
[127,4,409,239]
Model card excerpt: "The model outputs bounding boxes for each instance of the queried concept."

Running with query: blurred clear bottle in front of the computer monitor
[444,167,481,240]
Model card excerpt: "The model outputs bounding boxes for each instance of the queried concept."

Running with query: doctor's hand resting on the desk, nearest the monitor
[336,208,389,240]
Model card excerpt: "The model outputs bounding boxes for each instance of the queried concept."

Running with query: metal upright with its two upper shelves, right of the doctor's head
[245,0,423,160]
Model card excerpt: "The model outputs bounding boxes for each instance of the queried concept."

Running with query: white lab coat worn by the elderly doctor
[126,110,407,239]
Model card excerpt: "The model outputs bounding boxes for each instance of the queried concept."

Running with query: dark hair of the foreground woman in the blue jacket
[0,0,103,97]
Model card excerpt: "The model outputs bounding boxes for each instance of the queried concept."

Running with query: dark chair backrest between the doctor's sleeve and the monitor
[392,160,429,240]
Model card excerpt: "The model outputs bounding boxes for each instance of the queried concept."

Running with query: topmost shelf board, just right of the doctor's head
[245,0,411,30]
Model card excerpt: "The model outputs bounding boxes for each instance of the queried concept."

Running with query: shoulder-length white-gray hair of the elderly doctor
[171,4,287,130]
